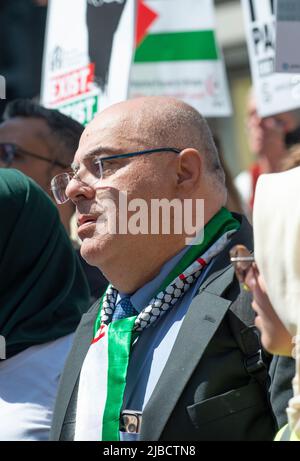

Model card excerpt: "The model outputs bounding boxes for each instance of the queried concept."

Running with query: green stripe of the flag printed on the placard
[134,30,219,63]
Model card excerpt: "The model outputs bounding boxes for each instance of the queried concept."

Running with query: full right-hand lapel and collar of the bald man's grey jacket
[140,215,253,441]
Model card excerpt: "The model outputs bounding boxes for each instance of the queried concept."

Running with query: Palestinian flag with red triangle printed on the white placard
[134,0,219,63]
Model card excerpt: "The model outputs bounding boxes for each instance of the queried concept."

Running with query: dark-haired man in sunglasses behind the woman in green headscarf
[0,99,107,303]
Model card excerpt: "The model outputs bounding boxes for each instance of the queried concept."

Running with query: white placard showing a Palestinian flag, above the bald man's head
[129,0,231,117]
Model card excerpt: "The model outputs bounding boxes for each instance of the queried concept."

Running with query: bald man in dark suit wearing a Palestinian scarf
[51,97,293,441]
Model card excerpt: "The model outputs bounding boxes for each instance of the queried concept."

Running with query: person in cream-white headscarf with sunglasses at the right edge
[231,167,300,441]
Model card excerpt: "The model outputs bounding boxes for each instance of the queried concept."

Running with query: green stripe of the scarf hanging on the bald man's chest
[101,316,136,441]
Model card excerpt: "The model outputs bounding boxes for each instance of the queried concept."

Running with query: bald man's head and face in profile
[70,97,227,293]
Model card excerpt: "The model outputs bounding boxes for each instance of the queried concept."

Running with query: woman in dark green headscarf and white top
[0,169,90,440]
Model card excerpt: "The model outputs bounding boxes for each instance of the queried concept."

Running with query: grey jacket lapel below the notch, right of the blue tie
[141,273,233,440]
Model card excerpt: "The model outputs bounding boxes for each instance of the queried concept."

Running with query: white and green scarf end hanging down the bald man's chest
[74,314,136,441]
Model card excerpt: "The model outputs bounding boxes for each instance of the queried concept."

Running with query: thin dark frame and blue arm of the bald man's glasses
[51,147,181,205]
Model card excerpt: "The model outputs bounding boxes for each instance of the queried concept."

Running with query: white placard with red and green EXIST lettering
[41,0,135,124]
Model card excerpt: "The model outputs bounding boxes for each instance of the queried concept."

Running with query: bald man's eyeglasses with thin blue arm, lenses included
[51,147,181,205]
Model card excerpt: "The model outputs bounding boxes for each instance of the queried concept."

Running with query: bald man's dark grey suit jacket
[50,217,294,441]
